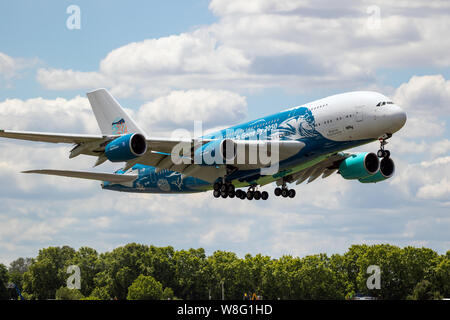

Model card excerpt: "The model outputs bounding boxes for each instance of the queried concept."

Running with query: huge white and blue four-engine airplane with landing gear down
[0,89,407,200]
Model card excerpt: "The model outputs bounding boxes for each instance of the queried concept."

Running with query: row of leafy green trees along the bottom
[0,243,450,300]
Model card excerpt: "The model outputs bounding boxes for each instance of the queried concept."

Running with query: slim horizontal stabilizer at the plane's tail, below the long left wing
[22,169,138,183]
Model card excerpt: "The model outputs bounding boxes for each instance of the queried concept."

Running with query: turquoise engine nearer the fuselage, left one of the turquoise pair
[339,152,380,180]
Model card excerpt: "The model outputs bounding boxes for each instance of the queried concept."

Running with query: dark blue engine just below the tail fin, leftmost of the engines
[105,133,147,162]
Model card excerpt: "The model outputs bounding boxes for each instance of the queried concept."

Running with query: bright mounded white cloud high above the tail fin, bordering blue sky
[100,30,249,76]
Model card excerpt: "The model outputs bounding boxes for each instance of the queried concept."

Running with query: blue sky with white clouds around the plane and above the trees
[0,0,450,264]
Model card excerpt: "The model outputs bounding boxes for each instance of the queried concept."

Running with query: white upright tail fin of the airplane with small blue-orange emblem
[86,89,146,136]
